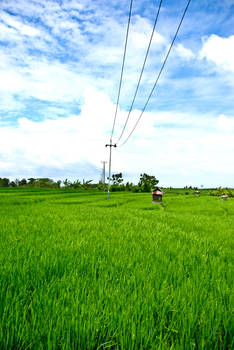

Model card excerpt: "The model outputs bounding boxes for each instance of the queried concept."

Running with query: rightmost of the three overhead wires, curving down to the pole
[119,0,191,147]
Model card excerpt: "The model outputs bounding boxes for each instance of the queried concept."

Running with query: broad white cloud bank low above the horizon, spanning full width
[0,88,234,186]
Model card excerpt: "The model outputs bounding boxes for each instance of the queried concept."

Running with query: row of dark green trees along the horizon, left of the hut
[0,173,159,192]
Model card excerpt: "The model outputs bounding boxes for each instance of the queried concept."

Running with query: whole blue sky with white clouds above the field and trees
[0,0,234,187]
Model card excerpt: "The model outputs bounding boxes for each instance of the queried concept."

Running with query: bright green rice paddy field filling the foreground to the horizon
[0,189,234,350]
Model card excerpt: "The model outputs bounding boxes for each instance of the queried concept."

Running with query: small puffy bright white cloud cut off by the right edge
[200,34,234,72]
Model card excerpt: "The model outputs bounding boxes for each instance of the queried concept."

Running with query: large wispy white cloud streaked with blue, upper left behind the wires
[0,1,170,109]
